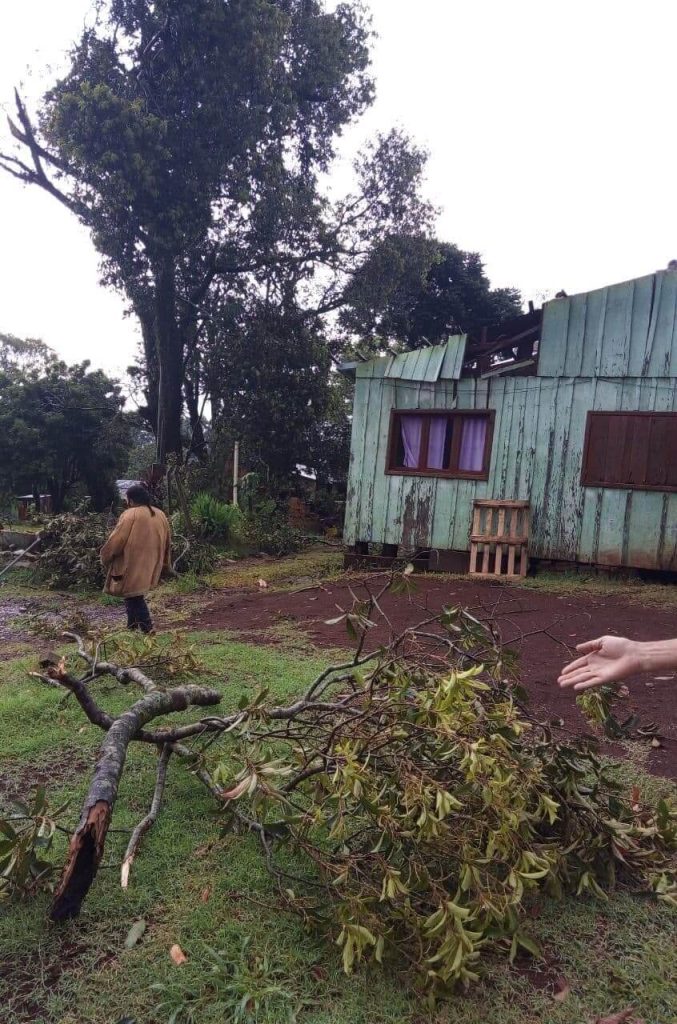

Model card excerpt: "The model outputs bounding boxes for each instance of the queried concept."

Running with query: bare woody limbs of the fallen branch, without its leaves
[39,590,528,921]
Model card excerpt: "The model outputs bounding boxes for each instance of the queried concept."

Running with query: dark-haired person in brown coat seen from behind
[100,483,171,633]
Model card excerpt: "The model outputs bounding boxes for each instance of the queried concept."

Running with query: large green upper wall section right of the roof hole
[538,270,677,378]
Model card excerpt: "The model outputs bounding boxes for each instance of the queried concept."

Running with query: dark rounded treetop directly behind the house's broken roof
[341,234,521,348]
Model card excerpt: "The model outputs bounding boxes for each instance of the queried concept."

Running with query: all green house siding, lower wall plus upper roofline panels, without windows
[345,271,677,570]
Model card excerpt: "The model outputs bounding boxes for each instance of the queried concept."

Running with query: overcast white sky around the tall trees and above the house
[0,0,677,373]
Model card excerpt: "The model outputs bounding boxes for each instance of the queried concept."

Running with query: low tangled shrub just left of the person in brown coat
[36,511,109,590]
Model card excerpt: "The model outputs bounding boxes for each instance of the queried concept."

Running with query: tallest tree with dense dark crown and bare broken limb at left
[0,0,427,460]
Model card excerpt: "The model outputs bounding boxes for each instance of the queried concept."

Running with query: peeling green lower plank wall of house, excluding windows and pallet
[345,372,677,570]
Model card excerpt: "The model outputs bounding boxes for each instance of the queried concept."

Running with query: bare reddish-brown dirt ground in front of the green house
[186,577,677,778]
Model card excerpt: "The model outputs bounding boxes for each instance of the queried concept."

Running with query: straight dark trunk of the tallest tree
[155,258,183,465]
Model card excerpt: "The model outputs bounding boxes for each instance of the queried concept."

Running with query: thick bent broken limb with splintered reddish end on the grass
[49,686,221,921]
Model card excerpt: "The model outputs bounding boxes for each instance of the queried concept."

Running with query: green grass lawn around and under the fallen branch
[0,554,677,1024]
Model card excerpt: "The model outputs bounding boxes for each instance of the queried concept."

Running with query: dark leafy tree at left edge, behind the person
[0,352,132,512]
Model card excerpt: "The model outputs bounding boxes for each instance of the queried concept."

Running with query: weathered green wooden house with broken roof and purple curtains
[343,269,677,570]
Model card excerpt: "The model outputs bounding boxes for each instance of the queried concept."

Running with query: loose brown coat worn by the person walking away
[100,505,171,597]
